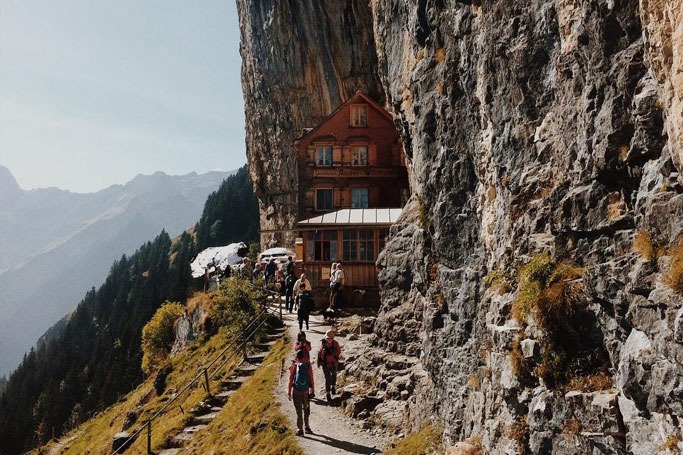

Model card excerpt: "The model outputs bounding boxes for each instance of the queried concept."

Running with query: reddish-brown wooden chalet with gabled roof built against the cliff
[295,92,410,300]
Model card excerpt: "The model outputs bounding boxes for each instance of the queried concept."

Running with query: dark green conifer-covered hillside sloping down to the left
[0,167,258,454]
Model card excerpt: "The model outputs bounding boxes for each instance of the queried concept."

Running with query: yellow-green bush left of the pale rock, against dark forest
[142,301,185,374]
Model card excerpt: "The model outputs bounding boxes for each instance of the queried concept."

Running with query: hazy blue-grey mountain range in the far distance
[0,166,231,375]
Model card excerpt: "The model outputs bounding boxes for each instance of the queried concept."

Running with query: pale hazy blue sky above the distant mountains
[0,0,246,192]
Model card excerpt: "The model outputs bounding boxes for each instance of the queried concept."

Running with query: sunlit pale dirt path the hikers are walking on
[276,313,388,455]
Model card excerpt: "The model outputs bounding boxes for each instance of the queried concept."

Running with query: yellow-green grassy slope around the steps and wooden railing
[33,333,302,455]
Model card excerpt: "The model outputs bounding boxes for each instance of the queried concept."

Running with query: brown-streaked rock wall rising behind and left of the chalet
[237,0,384,246]
